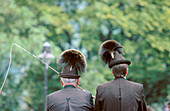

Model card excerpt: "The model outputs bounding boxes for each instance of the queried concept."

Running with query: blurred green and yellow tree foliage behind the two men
[0,0,170,111]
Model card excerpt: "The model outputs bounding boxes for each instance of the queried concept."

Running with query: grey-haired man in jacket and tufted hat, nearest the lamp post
[46,49,93,111]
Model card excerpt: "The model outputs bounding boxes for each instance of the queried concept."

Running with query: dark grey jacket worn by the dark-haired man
[94,78,147,111]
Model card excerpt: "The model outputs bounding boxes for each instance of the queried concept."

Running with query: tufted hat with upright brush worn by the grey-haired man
[58,49,86,79]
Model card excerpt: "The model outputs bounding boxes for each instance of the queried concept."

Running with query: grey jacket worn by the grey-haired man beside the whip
[46,85,93,111]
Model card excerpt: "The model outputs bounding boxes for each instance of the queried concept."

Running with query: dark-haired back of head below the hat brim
[112,64,128,78]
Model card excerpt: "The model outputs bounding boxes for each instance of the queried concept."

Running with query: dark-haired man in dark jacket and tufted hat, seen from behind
[94,40,147,111]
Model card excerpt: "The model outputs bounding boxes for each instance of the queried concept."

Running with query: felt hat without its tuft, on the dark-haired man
[108,52,131,68]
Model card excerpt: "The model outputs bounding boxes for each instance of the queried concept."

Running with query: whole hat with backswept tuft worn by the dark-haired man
[99,40,131,68]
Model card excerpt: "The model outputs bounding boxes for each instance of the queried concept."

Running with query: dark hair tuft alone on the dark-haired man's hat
[99,40,124,64]
